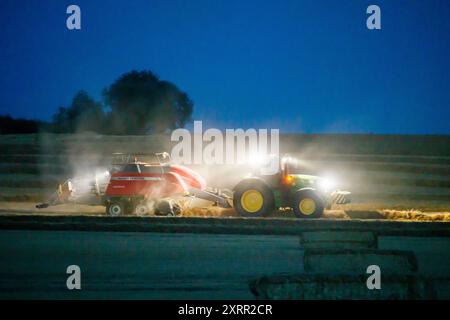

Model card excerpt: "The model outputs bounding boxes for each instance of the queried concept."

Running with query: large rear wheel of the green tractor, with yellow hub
[233,179,274,218]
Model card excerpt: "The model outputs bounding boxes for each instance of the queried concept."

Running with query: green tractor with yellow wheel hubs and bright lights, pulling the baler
[233,156,350,218]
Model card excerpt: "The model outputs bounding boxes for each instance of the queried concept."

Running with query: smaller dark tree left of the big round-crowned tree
[52,91,105,133]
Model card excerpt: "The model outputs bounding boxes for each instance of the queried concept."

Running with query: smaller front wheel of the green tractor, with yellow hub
[293,190,324,218]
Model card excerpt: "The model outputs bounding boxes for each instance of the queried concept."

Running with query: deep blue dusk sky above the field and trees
[0,0,450,134]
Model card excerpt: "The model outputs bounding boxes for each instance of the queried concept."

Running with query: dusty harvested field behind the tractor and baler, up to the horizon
[0,134,450,221]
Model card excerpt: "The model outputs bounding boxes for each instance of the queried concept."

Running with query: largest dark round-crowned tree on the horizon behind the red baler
[103,71,193,134]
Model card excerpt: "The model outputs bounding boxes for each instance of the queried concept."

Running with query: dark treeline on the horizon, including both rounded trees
[0,71,193,135]
